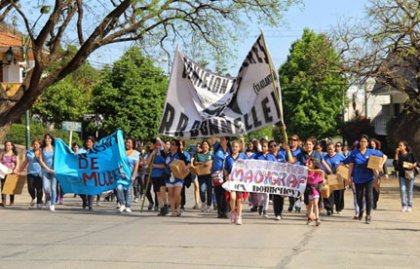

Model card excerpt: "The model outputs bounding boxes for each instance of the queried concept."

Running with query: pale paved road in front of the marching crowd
[0,176,420,269]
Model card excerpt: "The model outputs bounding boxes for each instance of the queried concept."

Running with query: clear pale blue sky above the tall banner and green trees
[89,0,367,75]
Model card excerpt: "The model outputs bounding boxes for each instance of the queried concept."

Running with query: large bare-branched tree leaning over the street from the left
[0,0,300,140]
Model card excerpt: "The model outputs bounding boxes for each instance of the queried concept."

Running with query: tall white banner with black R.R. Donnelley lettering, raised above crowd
[159,36,283,138]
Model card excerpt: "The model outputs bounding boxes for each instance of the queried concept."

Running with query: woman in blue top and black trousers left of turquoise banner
[19,139,43,208]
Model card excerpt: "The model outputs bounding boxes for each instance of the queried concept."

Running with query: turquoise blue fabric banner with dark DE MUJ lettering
[54,130,131,195]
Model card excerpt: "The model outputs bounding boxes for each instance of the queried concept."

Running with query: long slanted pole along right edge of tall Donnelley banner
[261,30,293,162]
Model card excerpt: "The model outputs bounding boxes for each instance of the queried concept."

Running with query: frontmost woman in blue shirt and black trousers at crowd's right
[346,135,386,224]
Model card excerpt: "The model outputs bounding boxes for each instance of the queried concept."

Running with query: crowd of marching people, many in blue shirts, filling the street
[0,134,418,226]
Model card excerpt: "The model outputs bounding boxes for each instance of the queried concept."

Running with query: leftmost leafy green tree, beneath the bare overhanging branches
[32,63,99,125]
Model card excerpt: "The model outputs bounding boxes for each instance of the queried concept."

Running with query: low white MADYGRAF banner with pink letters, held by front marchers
[222,160,308,198]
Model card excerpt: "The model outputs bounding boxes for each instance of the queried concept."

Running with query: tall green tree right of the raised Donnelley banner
[279,29,348,138]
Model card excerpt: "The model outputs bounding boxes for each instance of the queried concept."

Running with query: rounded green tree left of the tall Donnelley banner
[93,48,167,140]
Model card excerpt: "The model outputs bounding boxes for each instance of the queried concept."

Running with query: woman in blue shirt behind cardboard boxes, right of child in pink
[324,143,346,215]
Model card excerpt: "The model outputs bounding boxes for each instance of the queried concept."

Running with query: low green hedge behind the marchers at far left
[6,123,81,145]
